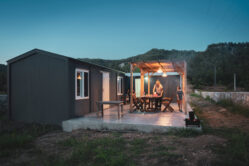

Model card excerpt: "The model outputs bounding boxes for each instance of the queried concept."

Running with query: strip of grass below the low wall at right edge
[217,100,249,117]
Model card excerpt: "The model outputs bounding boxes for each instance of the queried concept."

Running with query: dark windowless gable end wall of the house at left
[8,53,69,124]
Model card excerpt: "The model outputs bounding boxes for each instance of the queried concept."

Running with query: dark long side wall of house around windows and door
[69,60,124,117]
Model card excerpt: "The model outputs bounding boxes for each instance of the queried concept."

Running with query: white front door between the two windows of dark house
[102,72,110,109]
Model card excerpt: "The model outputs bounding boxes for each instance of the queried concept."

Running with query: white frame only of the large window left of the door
[75,69,90,100]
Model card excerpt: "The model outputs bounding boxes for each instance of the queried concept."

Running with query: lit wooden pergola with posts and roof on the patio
[130,60,187,114]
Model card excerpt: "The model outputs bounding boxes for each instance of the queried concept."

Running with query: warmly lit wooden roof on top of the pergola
[131,60,186,74]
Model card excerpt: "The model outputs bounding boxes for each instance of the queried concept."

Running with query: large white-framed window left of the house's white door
[75,69,89,99]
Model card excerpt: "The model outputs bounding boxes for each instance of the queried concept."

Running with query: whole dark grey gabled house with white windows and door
[8,49,125,124]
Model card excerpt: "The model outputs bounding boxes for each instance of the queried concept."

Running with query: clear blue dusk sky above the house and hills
[0,0,249,63]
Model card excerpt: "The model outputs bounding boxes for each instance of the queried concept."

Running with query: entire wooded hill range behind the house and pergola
[82,42,249,90]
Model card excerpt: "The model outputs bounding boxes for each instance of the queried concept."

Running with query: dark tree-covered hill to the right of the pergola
[188,42,249,90]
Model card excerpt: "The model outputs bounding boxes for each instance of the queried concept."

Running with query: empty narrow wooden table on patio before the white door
[96,101,124,118]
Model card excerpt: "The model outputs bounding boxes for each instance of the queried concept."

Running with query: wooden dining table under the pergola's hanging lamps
[140,95,162,112]
